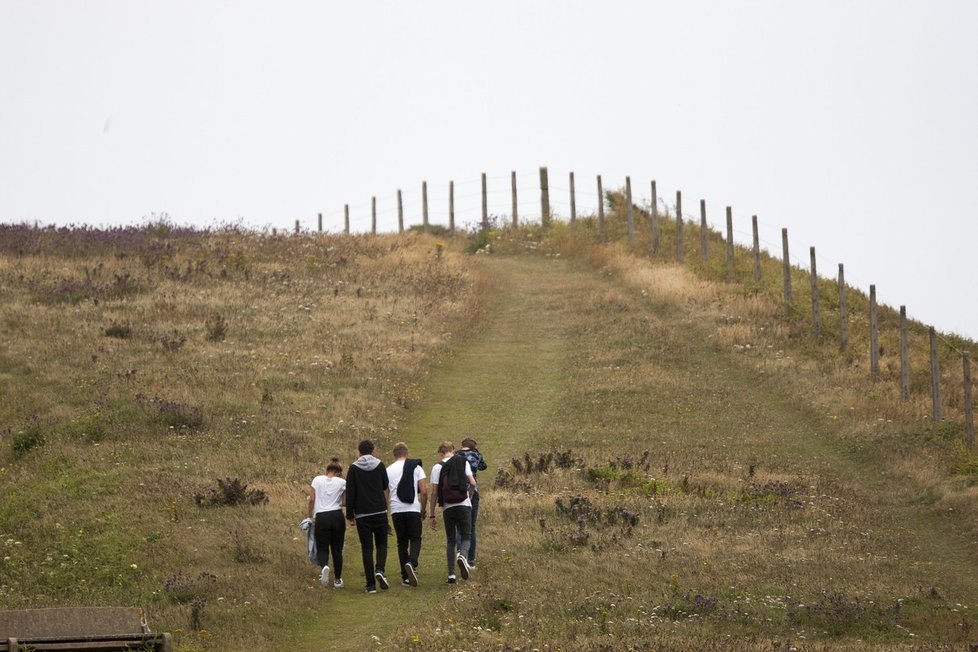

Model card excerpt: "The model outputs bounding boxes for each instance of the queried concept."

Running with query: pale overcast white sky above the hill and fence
[0,5,978,338]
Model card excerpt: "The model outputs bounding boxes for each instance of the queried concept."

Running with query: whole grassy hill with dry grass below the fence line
[0,206,978,650]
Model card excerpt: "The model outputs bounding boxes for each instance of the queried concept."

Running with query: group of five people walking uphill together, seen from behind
[307,439,487,593]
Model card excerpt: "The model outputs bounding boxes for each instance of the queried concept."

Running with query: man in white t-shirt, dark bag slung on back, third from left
[387,442,428,586]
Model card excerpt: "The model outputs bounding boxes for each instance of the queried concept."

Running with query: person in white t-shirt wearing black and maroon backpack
[428,441,475,584]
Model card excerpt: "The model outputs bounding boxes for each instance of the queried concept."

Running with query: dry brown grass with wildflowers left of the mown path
[0,223,481,649]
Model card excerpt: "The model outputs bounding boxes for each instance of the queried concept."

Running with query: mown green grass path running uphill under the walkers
[288,258,580,651]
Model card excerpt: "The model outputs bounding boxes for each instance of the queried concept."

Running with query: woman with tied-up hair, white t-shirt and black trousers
[309,457,346,589]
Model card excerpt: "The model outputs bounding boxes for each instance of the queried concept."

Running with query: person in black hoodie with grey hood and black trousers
[346,439,390,593]
